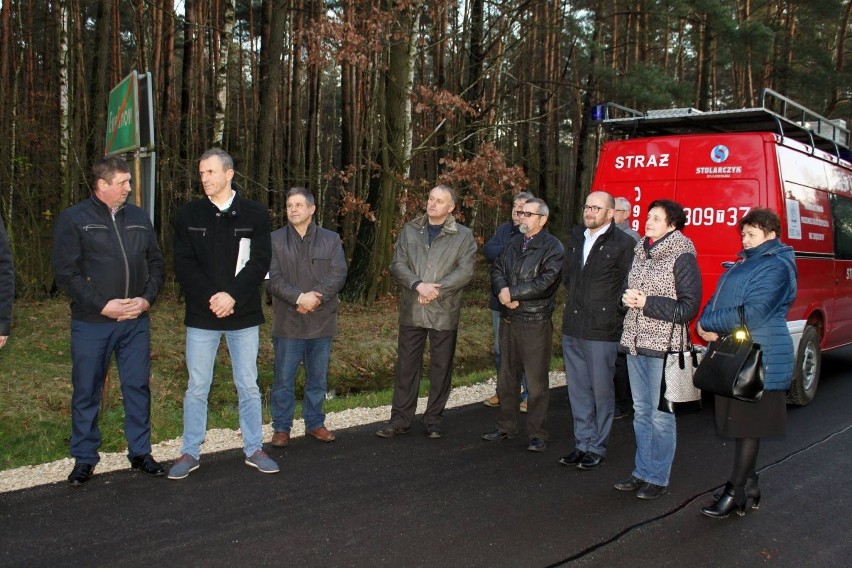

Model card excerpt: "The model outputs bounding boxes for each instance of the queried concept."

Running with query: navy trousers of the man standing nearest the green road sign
[71,317,151,465]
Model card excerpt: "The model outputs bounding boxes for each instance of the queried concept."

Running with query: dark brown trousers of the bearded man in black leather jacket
[497,318,553,440]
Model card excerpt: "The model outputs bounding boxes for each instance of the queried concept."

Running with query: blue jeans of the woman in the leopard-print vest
[627,355,677,487]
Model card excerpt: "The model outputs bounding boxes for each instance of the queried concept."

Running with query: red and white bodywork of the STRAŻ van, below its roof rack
[593,132,852,349]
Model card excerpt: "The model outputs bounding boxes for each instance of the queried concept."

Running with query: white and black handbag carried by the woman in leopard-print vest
[657,305,701,414]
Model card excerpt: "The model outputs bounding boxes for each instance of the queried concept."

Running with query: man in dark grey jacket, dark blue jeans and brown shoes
[267,187,347,448]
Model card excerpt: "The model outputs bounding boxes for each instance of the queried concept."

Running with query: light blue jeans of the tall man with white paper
[181,326,263,459]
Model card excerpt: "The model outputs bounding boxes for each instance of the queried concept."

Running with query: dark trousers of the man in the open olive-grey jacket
[390,325,458,428]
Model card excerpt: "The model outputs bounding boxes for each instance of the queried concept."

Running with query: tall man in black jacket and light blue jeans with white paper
[169,148,278,479]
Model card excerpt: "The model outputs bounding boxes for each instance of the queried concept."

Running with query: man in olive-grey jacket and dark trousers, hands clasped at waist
[376,185,476,438]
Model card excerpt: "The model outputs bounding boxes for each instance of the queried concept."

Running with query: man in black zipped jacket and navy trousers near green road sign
[51,157,165,486]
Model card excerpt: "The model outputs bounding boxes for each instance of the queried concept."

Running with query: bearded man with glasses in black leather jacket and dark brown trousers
[482,199,564,452]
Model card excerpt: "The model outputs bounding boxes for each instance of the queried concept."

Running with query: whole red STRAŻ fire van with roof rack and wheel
[593,90,852,405]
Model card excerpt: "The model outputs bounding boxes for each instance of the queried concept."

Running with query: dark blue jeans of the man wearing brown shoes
[272,337,331,432]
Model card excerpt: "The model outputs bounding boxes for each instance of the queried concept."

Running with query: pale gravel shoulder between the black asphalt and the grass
[0,371,565,493]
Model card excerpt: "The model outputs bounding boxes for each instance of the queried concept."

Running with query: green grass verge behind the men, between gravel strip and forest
[0,292,560,470]
